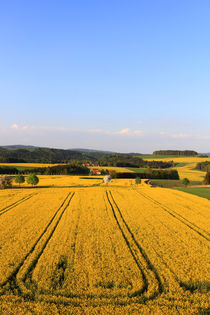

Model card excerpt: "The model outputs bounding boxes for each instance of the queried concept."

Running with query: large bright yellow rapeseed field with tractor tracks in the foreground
[0,175,210,314]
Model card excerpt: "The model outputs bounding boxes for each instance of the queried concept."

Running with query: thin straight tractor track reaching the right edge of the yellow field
[135,190,210,241]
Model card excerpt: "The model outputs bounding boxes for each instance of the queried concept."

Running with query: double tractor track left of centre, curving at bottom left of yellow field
[0,192,75,296]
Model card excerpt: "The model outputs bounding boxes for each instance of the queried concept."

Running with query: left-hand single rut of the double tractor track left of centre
[0,192,74,295]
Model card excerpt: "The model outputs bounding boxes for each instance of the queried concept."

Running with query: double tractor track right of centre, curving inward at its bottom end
[106,191,164,300]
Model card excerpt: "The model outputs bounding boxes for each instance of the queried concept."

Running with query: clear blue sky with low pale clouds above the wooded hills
[0,0,210,153]
